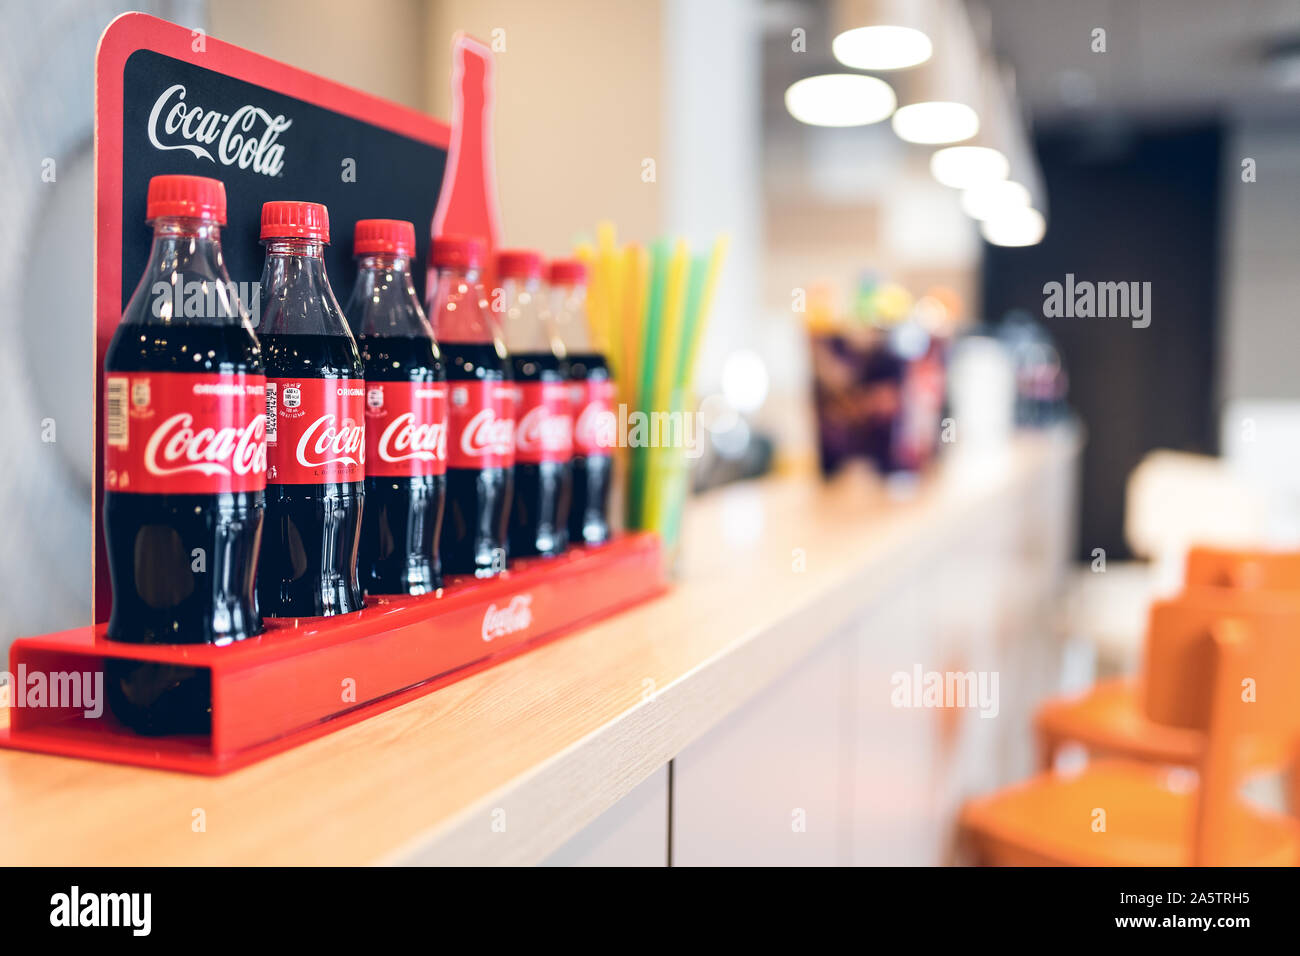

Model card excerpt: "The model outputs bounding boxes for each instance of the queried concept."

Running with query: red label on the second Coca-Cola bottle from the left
[267,378,365,485]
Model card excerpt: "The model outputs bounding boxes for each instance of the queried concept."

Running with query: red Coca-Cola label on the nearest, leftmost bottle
[104,372,267,494]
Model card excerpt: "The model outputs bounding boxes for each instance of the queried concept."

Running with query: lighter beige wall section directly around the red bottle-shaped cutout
[426,0,667,254]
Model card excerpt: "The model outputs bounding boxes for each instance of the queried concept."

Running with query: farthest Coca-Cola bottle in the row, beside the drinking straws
[549,259,618,545]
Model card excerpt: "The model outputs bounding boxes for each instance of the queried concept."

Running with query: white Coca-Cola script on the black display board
[150,83,294,176]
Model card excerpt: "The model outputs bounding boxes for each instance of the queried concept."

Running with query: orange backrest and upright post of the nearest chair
[1141,588,1300,866]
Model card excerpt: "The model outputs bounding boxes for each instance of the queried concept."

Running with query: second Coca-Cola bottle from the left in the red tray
[257,203,365,618]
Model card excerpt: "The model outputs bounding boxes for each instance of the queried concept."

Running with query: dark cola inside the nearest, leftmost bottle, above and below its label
[104,324,265,734]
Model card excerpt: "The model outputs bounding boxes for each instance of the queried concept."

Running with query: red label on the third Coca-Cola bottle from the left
[365,381,447,477]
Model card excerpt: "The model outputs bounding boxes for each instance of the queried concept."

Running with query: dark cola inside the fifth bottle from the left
[510,352,572,558]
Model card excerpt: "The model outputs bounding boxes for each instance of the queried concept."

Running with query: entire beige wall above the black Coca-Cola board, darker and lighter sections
[209,0,663,255]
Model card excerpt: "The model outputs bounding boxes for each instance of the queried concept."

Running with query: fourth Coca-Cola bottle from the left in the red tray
[429,237,515,578]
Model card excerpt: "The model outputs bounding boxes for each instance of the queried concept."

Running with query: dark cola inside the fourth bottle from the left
[438,342,514,578]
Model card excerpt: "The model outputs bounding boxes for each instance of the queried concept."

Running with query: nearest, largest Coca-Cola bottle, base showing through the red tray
[104,176,267,734]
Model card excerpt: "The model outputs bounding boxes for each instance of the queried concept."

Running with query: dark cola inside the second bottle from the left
[257,334,365,618]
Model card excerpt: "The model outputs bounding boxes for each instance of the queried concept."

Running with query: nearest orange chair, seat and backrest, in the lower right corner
[961,589,1300,866]
